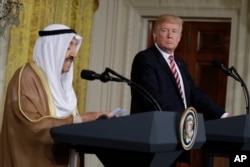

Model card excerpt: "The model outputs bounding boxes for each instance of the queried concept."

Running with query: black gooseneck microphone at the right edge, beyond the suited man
[212,60,250,114]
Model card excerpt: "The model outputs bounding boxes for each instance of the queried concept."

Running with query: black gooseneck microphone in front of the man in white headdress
[81,67,162,111]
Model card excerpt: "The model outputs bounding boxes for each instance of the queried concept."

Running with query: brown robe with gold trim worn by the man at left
[0,63,73,167]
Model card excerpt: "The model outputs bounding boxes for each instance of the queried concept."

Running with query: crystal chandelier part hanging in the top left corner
[0,0,23,36]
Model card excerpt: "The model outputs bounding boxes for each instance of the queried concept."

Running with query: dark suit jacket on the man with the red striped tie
[131,45,225,119]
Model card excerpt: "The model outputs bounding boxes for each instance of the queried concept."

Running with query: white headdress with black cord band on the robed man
[33,24,82,117]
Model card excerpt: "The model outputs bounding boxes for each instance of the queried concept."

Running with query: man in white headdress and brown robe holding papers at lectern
[0,24,110,167]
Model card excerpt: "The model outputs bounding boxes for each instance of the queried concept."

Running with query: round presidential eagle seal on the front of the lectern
[179,107,198,150]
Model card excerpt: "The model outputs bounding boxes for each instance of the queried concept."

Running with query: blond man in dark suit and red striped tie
[131,15,229,119]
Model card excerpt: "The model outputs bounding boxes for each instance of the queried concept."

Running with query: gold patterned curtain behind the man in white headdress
[5,0,98,113]
